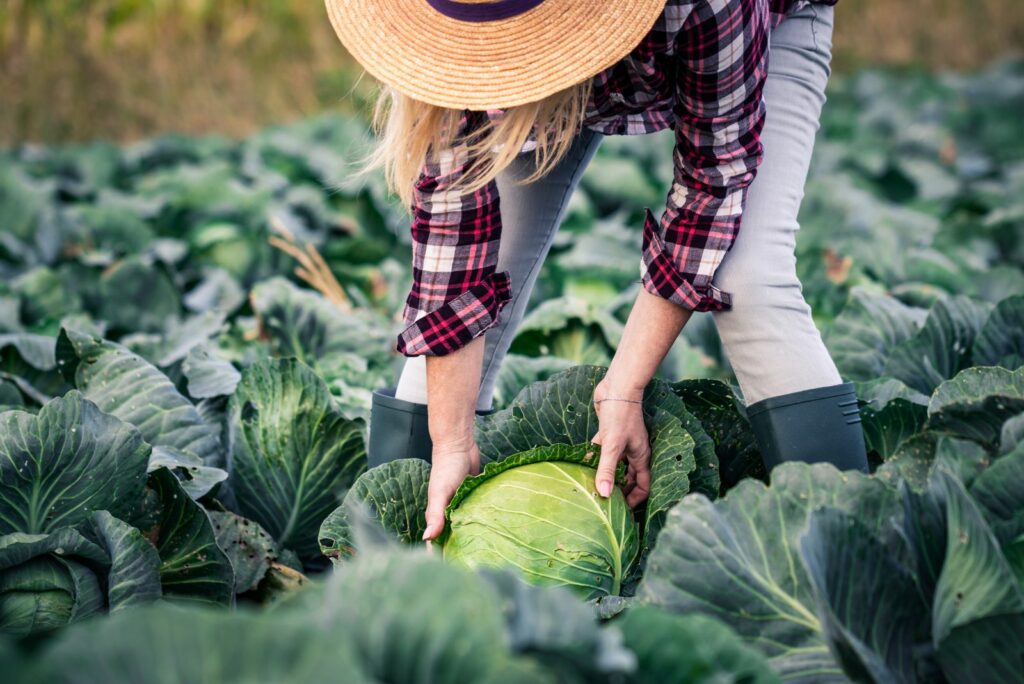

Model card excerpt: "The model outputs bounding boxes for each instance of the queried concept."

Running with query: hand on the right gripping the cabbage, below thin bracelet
[591,380,650,507]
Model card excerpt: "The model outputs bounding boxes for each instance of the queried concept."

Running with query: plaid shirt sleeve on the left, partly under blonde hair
[396,112,511,356]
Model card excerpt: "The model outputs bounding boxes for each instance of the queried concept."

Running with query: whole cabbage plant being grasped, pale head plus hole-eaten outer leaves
[318,367,719,598]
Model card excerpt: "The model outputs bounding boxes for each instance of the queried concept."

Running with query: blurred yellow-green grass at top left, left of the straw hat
[0,0,368,144]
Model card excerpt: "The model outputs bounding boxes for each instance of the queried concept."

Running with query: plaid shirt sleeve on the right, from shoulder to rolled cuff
[640,0,770,311]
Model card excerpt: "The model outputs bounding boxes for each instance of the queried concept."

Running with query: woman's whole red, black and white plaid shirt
[397,0,836,356]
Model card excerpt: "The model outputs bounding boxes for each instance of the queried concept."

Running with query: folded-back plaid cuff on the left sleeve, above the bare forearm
[396,271,512,356]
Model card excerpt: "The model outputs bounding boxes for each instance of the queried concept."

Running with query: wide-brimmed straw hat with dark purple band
[327,0,666,111]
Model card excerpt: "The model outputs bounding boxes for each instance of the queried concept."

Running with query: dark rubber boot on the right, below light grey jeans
[746,383,867,473]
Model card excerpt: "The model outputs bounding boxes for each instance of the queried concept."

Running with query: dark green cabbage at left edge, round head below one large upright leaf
[0,391,161,636]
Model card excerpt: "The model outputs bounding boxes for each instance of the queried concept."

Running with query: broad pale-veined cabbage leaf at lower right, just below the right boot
[637,464,898,682]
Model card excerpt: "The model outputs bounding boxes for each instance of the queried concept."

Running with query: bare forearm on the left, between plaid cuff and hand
[427,336,484,454]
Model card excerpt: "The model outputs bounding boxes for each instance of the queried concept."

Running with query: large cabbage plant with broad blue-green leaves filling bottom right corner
[637,454,1024,682]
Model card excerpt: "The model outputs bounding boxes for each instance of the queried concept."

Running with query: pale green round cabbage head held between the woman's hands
[443,444,640,599]
